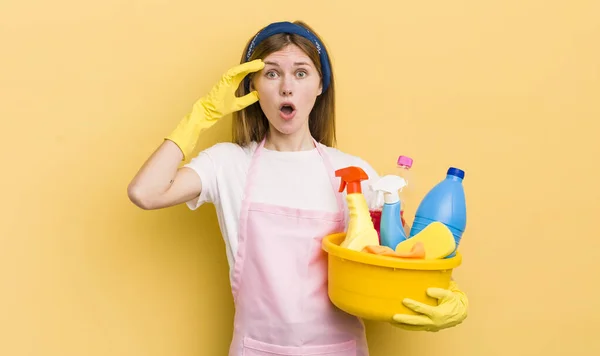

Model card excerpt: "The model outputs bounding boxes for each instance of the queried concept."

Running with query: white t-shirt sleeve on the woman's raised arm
[184,146,218,210]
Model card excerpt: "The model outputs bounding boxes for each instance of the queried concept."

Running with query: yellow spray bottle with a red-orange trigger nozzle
[335,166,379,251]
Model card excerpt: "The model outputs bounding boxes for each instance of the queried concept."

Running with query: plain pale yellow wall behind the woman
[0,0,600,356]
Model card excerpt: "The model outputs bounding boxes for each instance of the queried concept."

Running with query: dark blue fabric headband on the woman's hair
[246,22,331,92]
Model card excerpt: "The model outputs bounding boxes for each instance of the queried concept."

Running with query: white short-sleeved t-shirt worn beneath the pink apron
[185,142,378,276]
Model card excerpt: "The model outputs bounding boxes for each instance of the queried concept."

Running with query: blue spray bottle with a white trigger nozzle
[372,174,407,250]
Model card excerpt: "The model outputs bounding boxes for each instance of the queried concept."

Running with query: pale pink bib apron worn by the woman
[229,140,369,356]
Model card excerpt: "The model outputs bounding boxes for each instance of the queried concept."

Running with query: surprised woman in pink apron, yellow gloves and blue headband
[128,22,467,356]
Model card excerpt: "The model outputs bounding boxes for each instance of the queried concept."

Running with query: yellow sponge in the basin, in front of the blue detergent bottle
[396,221,456,260]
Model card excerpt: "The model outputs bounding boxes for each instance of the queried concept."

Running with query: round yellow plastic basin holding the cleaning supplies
[322,233,462,322]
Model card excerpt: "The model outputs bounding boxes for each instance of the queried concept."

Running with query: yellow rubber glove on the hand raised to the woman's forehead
[165,59,265,160]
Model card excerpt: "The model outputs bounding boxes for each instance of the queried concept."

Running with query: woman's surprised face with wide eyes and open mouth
[252,45,321,135]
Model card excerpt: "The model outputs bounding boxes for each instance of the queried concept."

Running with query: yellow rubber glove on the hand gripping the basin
[392,281,469,331]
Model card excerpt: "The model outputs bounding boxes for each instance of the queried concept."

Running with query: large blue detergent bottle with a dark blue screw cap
[409,167,467,258]
